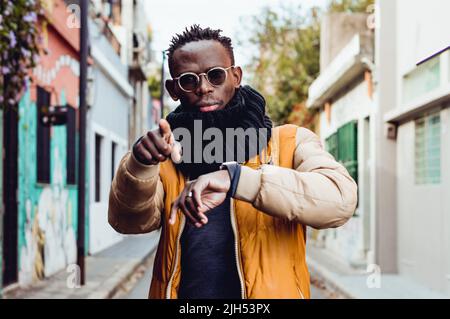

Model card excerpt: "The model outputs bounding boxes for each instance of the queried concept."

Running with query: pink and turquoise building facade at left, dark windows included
[2,0,79,286]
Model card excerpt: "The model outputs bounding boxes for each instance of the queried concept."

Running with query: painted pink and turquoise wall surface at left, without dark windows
[18,0,79,285]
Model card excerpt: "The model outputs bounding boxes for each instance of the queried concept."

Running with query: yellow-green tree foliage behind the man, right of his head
[240,0,374,128]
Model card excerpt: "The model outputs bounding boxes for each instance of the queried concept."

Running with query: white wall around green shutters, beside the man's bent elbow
[319,80,374,266]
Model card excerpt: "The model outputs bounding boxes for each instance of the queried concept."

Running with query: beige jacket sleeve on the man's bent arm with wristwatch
[235,128,357,229]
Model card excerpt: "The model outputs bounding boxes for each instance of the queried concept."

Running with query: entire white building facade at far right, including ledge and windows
[379,0,450,296]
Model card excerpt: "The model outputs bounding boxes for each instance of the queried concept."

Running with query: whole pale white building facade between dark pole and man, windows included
[87,2,134,254]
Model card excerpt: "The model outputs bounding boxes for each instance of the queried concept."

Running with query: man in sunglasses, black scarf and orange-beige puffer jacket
[109,25,357,298]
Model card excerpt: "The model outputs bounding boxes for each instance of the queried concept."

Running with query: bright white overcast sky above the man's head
[145,0,328,65]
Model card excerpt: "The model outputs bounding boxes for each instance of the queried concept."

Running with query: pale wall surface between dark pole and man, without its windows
[87,21,134,254]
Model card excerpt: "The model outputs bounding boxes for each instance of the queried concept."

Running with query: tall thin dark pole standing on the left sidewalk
[77,0,89,286]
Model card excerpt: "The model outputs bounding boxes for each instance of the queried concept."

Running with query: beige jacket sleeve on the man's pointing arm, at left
[108,152,164,234]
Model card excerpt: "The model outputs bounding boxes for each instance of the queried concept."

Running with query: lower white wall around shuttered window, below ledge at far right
[397,105,450,295]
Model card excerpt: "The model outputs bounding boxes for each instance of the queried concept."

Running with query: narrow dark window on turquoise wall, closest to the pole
[66,105,77,185]
